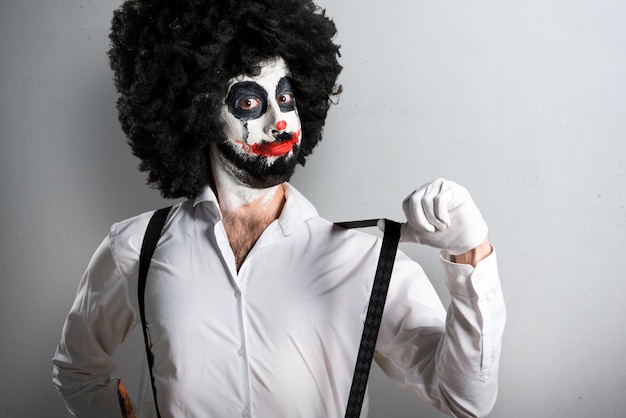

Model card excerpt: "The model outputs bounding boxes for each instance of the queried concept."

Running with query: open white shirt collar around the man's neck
[193,182,318,235]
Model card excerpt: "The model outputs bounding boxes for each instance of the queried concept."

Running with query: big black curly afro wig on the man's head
[109,0,341,198]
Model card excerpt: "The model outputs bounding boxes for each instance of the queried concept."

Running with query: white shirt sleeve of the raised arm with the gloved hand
[375,250,506,417]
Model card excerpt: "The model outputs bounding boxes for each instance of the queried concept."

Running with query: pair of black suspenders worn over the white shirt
[137,206,400,418]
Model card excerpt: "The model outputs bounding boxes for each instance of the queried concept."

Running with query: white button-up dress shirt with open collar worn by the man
[53,184,505,418]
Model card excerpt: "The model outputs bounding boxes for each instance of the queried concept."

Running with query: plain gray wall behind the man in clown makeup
[0,0,626,418]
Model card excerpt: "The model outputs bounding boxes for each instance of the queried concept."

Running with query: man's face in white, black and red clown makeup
[214,58,302,188]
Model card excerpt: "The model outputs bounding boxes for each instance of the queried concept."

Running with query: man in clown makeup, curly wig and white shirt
[53,0,505,418]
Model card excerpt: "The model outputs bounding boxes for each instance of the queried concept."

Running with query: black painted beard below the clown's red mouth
[217,142,300,189]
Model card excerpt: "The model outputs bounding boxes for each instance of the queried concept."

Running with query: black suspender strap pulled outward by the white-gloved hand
[345,219,401,418]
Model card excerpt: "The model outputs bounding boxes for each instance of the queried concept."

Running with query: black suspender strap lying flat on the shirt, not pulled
[137,206,171,418]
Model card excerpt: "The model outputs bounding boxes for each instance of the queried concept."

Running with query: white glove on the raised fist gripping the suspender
[388,178,487,255]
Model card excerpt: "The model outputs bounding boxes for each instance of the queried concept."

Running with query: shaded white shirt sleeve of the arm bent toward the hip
[52,237,136,418]
